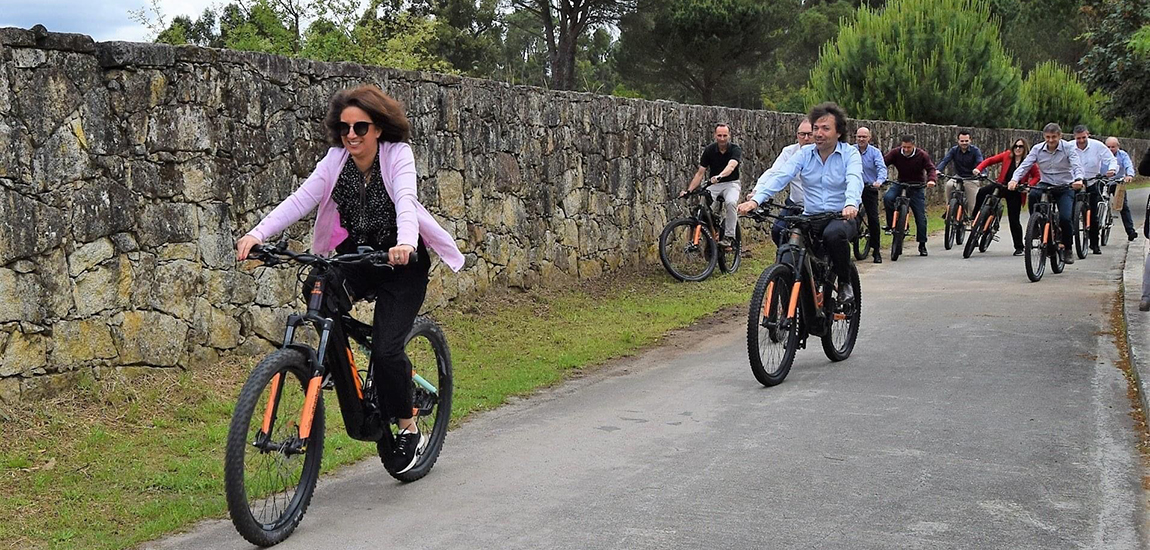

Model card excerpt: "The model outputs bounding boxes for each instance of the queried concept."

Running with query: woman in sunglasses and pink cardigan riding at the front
[236,85,463,473]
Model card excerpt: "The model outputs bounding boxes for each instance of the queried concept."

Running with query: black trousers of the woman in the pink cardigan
[304,242,431,419]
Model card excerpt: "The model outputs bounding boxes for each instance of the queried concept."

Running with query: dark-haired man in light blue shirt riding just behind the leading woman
[738,102,863,304]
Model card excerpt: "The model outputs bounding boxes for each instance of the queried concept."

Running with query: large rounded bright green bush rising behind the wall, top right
[807,0,1022,128]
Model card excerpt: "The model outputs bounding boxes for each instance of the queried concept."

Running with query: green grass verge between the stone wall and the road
[0,242,774,550]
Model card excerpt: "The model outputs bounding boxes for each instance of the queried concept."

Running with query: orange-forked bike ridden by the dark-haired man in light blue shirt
[746,208,863,387]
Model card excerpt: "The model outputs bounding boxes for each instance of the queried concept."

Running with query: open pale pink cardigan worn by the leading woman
[247,142,463,272]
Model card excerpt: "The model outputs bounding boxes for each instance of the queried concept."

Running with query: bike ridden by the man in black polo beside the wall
[659,185,743,282]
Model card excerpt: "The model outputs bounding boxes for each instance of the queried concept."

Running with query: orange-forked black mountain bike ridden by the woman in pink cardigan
[224,243,452,547]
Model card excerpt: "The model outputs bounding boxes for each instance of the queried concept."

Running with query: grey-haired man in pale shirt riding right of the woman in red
[1006,122,1082,263]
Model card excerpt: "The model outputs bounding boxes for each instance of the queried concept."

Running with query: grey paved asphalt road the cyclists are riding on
[146,190,1148,549]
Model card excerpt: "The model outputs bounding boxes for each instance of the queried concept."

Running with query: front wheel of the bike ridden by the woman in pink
[224,349,324,547]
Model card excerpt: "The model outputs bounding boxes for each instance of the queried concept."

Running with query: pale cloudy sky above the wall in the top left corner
[0,0,223,41]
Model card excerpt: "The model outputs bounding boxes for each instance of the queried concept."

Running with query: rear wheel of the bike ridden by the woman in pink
[380,315,454,482]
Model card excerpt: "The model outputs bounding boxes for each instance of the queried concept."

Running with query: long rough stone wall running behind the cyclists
[0,28,1145,402]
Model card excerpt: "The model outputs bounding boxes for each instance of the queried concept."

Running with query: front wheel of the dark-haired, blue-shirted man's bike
[746,263,799,387]
